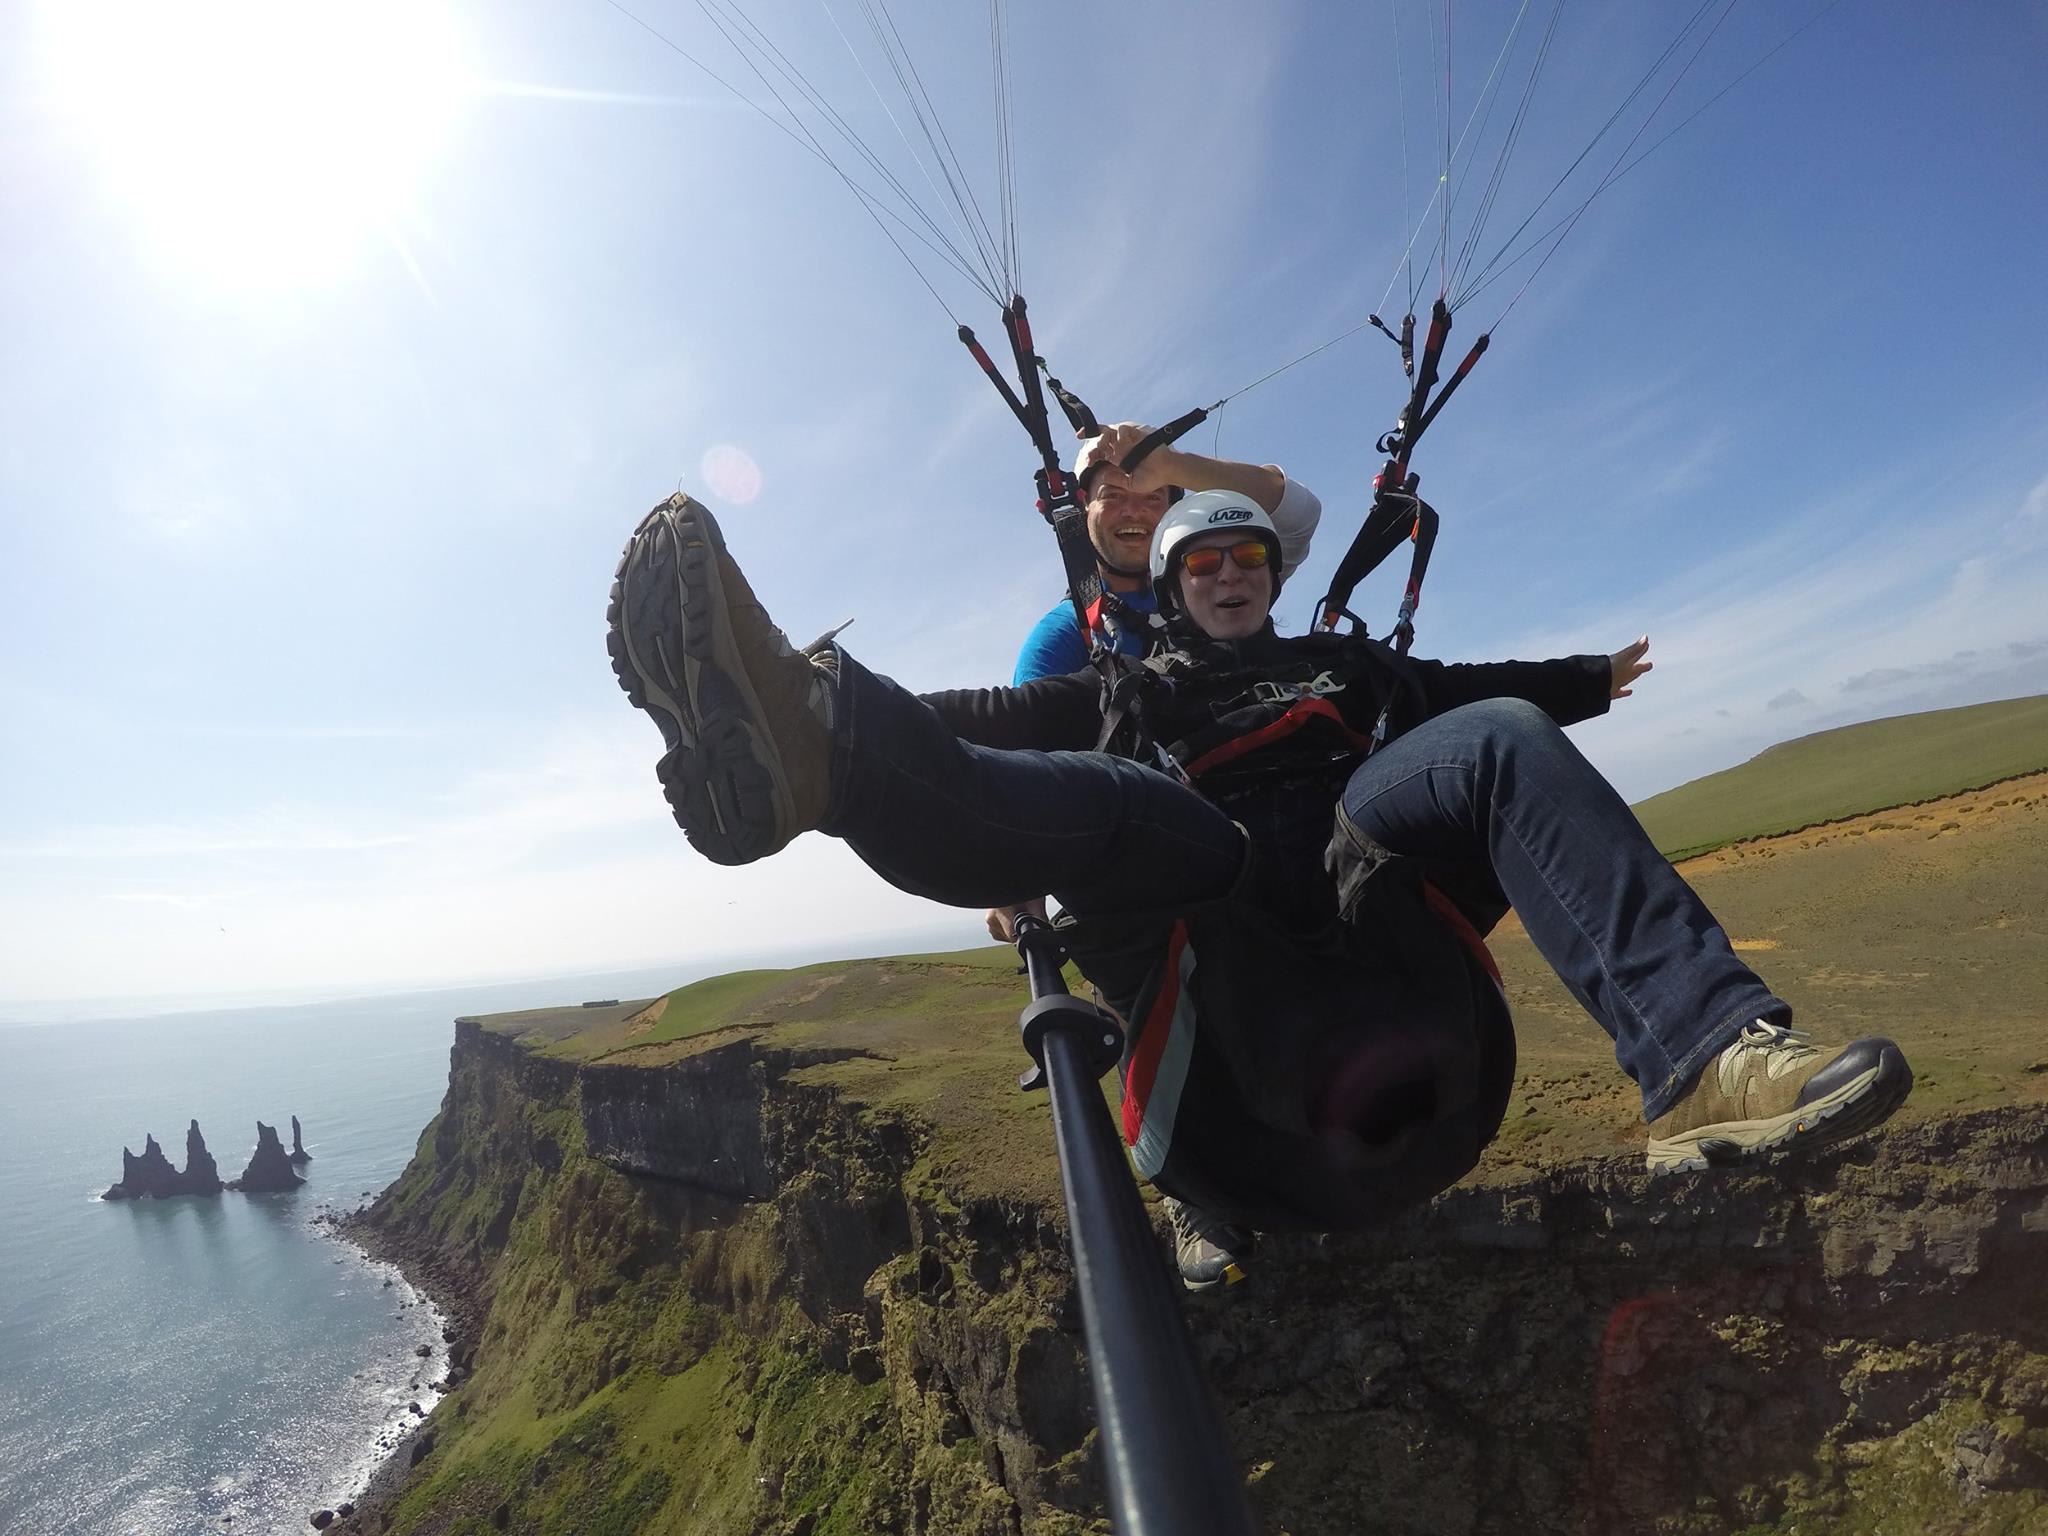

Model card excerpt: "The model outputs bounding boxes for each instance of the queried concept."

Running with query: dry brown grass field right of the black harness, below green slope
[1475,774,2048,1178]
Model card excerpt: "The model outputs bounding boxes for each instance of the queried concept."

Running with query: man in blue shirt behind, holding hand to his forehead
[1012,422,1323,688]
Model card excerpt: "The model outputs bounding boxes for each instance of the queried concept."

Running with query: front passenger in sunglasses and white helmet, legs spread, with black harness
[608,494,1913,1286]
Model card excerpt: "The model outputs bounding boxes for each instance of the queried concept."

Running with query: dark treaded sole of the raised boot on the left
[604,496,795,864]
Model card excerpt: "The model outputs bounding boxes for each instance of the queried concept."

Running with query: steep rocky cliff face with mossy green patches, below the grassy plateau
[358,1024,2048,1536]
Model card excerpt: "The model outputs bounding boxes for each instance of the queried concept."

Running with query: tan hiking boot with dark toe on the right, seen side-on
[1649,1018,1913,1174]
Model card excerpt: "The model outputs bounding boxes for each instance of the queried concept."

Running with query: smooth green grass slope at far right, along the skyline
[1634,696,2048,858]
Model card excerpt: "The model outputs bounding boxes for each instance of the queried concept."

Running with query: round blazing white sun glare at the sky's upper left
[45,0,465,289]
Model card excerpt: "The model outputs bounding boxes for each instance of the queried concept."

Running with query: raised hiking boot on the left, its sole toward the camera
[604,494,836,864]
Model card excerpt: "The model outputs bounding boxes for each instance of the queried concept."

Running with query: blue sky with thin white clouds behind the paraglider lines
[0,0,2048,1016]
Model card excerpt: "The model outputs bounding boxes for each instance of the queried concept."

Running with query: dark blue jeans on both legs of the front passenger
[823,653,1792,1120]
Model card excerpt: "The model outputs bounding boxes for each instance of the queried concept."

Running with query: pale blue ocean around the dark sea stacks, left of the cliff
[0,967,737,1536]
